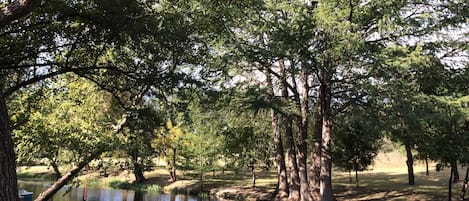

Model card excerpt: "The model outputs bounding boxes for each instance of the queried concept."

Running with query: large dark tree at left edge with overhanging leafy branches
[0,0,210,201]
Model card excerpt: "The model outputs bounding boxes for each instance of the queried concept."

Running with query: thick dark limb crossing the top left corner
[0,0,41,29]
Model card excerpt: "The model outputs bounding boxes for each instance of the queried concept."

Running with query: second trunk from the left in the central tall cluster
[279,61,300,200]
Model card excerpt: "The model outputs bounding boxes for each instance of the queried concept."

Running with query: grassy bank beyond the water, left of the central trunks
[17,166,276,201]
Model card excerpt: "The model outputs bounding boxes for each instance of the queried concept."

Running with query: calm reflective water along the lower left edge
[18,180,208,201]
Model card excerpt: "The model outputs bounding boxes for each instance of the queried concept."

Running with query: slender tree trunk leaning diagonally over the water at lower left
[34,157,90,201]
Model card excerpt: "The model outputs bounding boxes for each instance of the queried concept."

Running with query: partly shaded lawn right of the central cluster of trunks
[333,152,467,200]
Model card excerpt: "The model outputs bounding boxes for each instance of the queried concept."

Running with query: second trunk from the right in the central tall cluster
[309,101,322,200]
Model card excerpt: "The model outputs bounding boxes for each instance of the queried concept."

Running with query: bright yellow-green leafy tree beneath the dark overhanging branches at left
[9,74,120,180]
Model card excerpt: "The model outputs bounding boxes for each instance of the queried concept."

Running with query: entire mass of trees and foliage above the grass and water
[0,0,469,201]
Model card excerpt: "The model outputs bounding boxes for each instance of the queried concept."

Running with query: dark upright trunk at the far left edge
[0,89,19,201]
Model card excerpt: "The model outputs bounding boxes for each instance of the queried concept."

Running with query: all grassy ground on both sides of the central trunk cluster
[18,152,465,200]
